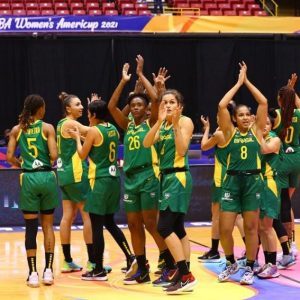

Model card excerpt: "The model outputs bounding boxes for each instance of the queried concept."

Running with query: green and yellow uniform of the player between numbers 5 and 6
[56,118,89,203]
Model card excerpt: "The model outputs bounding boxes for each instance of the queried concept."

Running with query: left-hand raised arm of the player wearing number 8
[218,64,246,141]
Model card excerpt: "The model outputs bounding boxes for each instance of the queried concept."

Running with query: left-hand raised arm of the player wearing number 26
[107,63,131,130]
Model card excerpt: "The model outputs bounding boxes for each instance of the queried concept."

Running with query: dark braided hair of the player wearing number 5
[19,94,45,131]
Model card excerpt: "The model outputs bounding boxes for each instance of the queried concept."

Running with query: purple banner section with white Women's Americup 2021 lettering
[0,15,152,33]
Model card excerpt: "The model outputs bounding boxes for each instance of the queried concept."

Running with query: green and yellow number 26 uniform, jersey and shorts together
[123,120,159,212]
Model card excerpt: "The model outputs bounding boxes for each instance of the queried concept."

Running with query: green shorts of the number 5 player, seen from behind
[19,171,58,212]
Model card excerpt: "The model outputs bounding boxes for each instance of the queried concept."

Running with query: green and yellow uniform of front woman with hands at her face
[157,116,192,213]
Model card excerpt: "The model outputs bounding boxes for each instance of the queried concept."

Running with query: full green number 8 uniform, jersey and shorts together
[221,128,264,213]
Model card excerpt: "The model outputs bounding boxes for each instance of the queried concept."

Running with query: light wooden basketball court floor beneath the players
[0,225,300,300]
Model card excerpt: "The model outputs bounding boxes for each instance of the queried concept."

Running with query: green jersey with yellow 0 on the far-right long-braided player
[273,109,300,149]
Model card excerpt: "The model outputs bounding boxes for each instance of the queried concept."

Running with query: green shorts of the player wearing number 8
[220,174,264,213]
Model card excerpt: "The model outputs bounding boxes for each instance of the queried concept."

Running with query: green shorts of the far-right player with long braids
[277,151,300,188]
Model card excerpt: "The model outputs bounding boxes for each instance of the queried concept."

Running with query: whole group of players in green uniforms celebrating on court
[7,55,300,294]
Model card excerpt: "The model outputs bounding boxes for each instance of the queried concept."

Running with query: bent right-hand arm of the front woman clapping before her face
[172,107,194,156]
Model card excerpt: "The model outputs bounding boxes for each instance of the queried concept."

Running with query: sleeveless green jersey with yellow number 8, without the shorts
[224,128,261,171]
